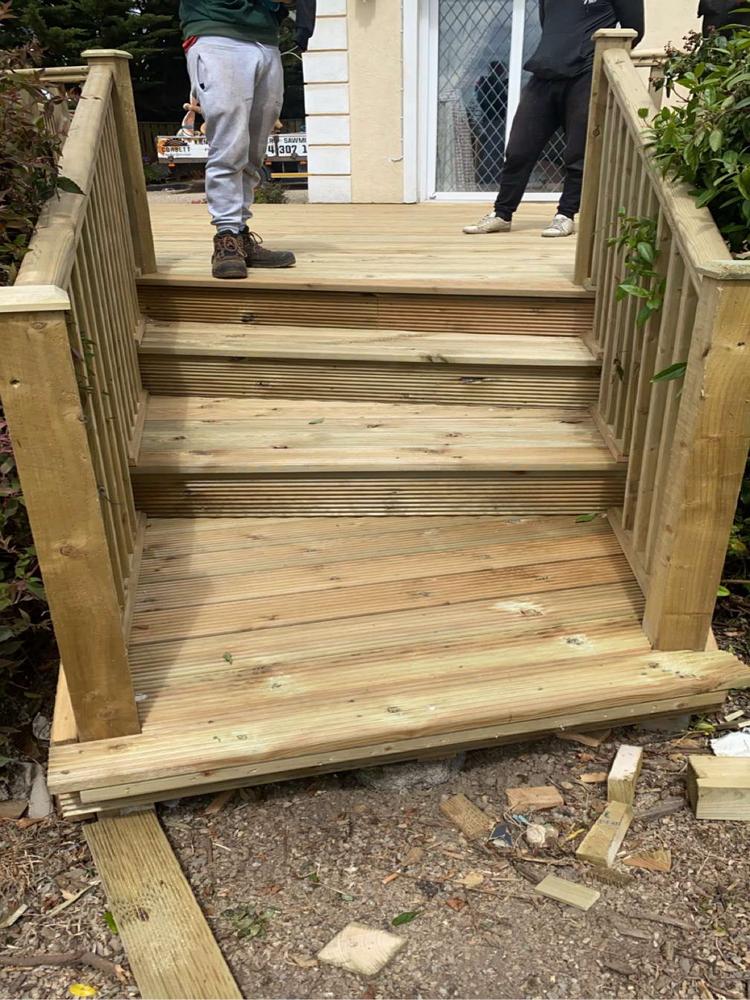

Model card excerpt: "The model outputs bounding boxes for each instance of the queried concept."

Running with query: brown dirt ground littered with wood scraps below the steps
[0,694,750,1000]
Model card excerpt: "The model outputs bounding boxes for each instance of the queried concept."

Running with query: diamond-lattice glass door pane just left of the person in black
[437,0,513,192]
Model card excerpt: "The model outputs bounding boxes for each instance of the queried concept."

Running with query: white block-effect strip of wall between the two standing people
[302,0,352,202]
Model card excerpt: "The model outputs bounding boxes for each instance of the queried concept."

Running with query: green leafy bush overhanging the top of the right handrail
[651,29,750,254]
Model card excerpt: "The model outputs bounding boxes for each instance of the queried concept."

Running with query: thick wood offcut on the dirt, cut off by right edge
[688,755,750,820]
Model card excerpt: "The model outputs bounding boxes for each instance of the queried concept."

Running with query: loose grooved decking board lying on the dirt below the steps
[84,810,242,1000]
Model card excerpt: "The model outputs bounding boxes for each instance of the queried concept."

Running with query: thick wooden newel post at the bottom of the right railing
[643,261,750,650]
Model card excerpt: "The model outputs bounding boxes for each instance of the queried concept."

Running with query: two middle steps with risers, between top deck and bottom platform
[134,312,624,516]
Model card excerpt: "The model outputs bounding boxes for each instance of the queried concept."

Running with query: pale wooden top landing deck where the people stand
[142,200,590,298]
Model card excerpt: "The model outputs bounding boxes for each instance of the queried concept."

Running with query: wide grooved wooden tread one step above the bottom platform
[137,396,622,477]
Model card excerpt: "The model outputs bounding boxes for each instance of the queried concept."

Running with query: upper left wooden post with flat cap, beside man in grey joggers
[81,49,156,274]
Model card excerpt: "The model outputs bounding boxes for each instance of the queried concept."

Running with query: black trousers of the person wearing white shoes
[495,73,591,220]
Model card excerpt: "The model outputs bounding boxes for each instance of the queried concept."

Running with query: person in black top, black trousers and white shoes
[464,0,644,237]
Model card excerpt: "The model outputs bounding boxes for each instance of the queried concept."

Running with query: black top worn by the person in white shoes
[524,0,645,80]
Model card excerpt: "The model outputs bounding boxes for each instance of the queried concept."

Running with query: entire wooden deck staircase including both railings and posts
[0,41,750,816]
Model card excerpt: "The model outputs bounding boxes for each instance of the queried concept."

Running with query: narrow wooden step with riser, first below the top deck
[140,322,599,407]
